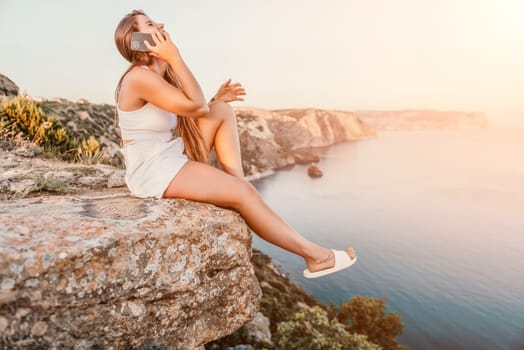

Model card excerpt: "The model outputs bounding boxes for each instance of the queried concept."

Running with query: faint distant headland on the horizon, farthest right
[355,110,489,130]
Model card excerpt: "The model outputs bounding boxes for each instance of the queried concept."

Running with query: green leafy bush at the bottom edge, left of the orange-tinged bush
[273,306,381,350]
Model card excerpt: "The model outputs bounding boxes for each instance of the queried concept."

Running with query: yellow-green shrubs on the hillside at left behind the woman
[0,96,103,163]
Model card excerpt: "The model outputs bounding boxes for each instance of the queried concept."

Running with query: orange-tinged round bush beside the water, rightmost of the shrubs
[338,295,408,350]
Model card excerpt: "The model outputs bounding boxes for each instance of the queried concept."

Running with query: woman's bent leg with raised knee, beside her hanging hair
[197,101,244,178]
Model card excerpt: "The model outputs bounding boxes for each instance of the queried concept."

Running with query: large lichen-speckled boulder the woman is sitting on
[0,191,261,349]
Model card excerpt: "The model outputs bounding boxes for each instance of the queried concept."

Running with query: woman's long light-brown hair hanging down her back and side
[115,10,208,163]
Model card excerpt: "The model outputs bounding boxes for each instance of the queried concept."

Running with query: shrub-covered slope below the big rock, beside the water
[206,249,408,350]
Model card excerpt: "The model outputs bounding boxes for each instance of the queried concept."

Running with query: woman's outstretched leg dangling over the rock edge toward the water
[164,161,354,272]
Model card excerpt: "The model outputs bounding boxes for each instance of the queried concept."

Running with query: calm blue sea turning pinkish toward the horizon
[254,129,524,349]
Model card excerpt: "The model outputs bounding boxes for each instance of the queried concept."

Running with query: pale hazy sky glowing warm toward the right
[0,0,524,127]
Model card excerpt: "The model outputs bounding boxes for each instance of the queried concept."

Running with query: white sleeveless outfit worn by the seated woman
[116,102,189,198]
